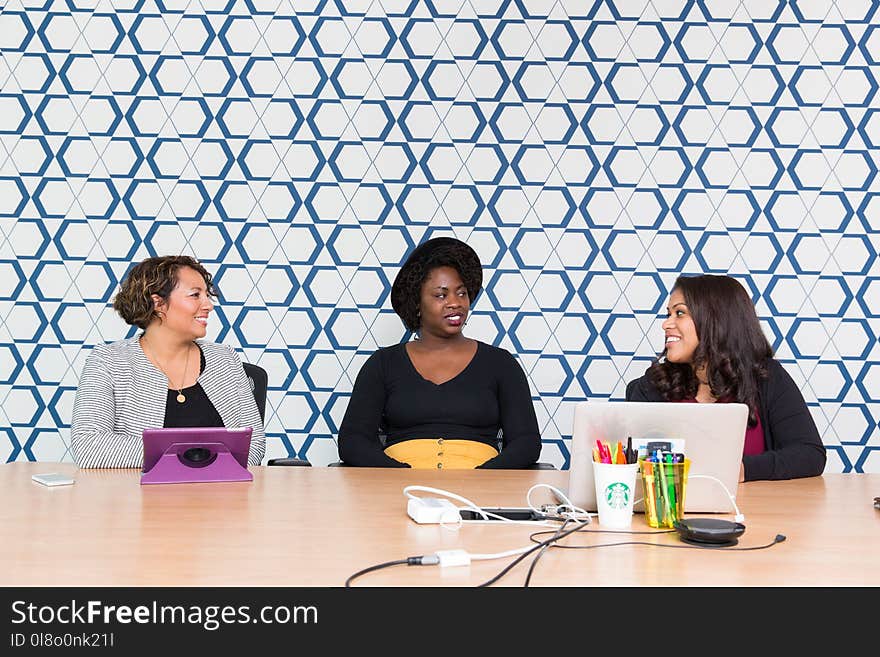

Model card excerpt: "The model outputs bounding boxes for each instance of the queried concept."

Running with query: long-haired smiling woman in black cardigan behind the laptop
[626,275,825,481]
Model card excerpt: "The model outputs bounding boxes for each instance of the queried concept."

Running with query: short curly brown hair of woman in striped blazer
[113,255,217,329]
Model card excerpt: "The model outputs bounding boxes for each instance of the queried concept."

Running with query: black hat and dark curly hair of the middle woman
[391,237,483,331]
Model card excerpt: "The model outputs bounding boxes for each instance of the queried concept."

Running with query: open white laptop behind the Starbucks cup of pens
[567,401,749,513]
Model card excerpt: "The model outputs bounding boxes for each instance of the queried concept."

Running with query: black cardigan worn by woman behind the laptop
[626,359,826,481]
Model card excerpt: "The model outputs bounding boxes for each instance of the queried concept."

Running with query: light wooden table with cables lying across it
[0,462,880,587]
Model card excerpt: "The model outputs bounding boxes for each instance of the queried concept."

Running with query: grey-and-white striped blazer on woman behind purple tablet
[70,337,266,468]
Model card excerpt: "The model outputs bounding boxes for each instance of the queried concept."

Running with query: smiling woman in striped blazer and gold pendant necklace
[70,256,266,468]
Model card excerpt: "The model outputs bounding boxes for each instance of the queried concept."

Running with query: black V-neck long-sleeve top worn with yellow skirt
[339,342,541,468]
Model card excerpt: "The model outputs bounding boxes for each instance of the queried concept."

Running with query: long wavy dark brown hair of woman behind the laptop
[645,274,773,426]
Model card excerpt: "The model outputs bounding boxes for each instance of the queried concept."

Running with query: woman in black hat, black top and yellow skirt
[339,237,541,469]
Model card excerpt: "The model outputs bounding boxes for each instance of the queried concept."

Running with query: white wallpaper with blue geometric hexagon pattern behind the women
[0,0,880,472]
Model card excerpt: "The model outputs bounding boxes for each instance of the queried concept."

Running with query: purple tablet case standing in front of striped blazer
[141,427,254,484]
